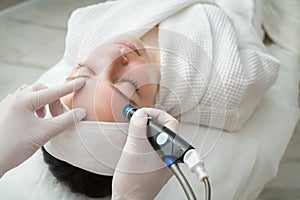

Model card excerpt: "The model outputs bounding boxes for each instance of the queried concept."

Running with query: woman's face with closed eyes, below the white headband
[63,36,160,122]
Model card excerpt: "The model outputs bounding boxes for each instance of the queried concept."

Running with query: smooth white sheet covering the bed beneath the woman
[0,46,300,200]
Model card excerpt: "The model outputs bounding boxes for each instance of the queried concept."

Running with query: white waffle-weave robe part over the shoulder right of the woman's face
[156,4,278,131]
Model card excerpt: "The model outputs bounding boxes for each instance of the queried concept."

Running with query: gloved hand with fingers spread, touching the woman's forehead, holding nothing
[0,79,86,177]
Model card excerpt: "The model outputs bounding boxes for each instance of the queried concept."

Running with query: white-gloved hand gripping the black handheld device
[112,108,179,200]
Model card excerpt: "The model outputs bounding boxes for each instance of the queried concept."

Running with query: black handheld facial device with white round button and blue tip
[123,105,194,167]
